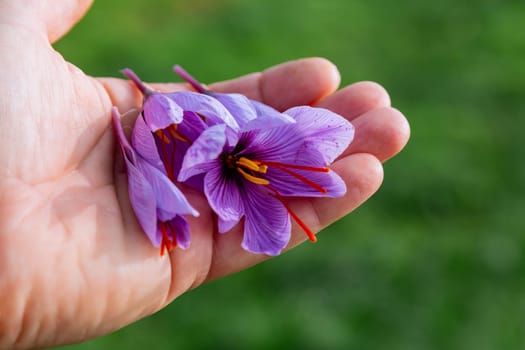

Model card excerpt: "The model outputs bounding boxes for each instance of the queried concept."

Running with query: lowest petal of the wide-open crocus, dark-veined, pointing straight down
[242,185,291,255]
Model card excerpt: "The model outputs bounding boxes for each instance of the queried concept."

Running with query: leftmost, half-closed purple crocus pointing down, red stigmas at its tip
[112,107,199,256]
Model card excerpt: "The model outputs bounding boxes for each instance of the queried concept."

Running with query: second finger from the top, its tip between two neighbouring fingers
[316,81,390,120]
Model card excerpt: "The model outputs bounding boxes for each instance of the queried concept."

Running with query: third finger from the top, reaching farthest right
[342,107,410,162]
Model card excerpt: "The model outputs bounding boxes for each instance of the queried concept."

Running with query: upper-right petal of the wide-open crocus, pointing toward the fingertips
[285,106,354,165]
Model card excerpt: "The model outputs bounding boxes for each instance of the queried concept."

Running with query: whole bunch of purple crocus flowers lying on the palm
[113,66,354,255]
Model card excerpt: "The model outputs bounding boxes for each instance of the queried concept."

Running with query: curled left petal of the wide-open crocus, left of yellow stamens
[178,124,226,182]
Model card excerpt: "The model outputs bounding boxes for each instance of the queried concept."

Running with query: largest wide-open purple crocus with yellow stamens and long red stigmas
[178,106,354,255]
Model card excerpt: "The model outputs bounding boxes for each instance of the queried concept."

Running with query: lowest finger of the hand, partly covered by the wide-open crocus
[206,153,383,281]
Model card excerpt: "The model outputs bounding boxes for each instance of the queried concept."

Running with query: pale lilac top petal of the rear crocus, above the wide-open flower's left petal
[167,91,239,130]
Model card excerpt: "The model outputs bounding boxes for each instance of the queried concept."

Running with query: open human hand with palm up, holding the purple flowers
[0,0,409,348]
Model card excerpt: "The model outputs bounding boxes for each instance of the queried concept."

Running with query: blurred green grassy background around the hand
[56,0,525,350]
